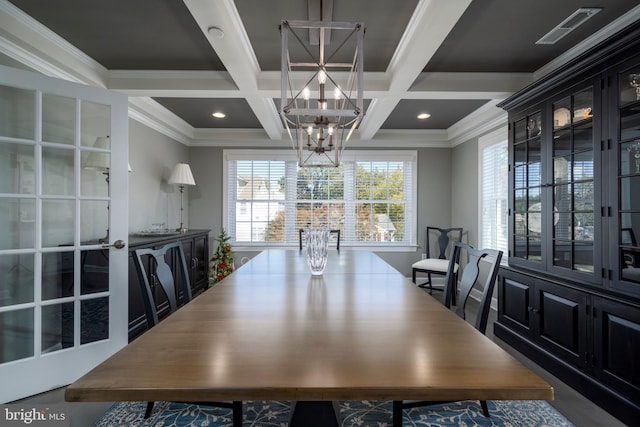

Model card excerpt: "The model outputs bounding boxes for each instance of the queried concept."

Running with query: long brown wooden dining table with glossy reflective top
[65,249,553,426]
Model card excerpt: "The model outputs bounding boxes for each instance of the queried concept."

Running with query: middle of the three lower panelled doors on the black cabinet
[535,281,587,366]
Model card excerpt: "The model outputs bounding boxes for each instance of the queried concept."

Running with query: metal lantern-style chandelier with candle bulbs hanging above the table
[279,1,364,167]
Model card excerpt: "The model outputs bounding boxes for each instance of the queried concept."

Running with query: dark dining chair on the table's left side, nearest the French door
[133,242,242,427]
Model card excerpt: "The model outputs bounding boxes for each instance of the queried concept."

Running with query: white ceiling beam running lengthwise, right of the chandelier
[360,0,471,139]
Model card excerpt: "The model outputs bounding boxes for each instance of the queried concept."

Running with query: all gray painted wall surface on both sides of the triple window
[129,120,504,276]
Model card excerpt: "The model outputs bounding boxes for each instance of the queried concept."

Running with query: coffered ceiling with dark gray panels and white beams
[0,0,640,144]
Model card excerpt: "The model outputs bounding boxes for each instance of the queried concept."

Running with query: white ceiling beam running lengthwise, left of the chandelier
[184,0,282,139]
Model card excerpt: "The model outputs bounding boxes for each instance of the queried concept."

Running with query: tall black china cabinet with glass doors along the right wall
[495,20,640,424]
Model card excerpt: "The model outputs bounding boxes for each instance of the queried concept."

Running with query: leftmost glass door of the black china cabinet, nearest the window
[511,111,543,262]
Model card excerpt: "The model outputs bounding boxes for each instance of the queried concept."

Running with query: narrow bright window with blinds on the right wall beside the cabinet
[478,128,509,254]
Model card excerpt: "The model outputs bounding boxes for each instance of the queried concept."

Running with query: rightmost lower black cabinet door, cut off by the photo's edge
[594,298,640,402]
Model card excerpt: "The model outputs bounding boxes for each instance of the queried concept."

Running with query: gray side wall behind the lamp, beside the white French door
[129,120,189,233]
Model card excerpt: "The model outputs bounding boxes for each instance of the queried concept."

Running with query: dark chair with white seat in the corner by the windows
[411,227,462,291]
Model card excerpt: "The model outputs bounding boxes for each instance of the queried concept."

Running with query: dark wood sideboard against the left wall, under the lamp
[129,230,209,340]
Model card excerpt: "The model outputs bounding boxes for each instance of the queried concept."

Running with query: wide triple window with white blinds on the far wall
[224,150,417,246]
